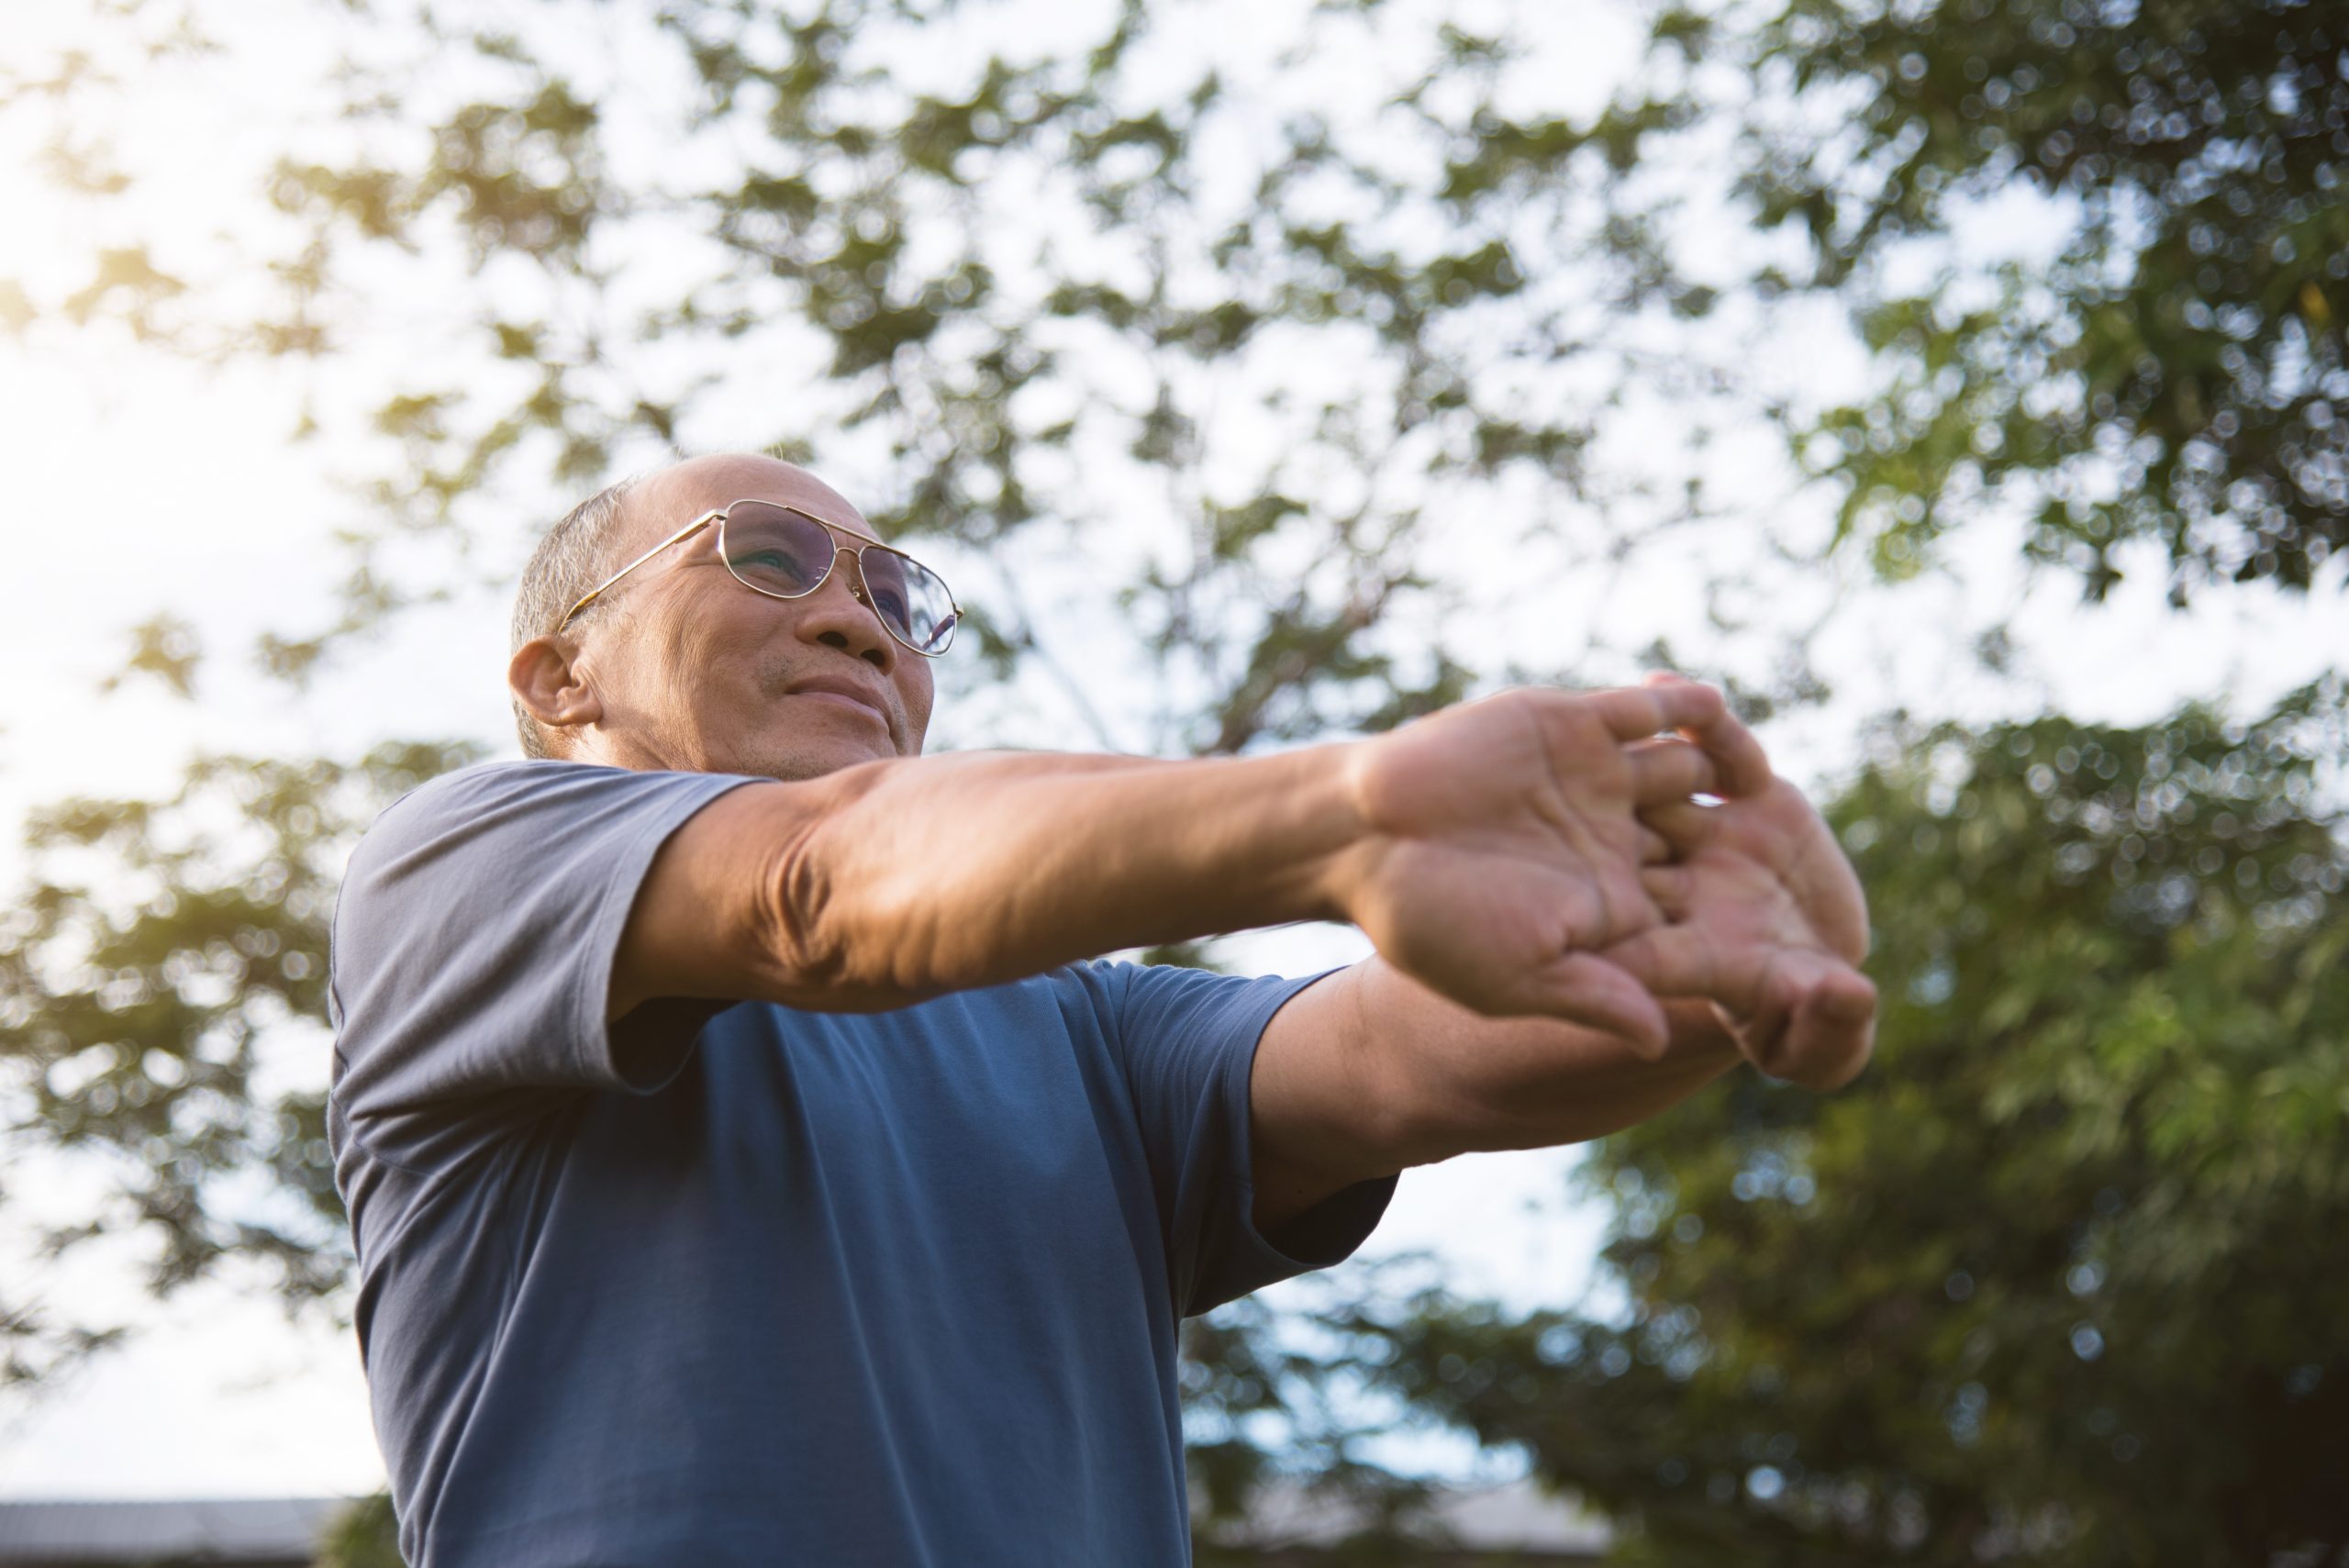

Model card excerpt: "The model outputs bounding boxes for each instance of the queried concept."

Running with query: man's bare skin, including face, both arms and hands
[510,455,1875,1241]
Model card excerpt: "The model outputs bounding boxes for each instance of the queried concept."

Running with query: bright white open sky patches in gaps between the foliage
[0,7,2349,1496]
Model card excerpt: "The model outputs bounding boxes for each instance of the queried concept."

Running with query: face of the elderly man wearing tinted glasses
[540,455,932,779]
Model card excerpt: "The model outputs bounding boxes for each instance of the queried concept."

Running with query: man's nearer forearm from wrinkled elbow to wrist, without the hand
[773,747,1360,1005]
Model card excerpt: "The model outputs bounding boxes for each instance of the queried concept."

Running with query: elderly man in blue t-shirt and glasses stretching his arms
[331,458,1875,1568]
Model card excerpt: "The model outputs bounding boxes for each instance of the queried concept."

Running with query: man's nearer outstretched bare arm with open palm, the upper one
[611,685,1724,1032]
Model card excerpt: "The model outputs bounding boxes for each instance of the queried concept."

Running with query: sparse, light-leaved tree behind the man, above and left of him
[0,0,1785,1540]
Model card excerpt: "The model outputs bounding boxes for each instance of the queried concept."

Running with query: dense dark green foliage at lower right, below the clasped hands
[1364,678,2349,1568]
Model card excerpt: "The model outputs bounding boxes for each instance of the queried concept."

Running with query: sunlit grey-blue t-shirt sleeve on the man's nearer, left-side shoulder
[328,761,750,1160]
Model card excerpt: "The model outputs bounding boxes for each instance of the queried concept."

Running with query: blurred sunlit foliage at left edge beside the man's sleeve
[0,744,473,1380]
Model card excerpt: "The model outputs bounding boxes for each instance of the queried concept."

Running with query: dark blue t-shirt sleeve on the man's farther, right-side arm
[1113,964,1396,1317]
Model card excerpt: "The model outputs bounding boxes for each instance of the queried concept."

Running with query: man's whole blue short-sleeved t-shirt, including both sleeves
[328,762,1393,1568]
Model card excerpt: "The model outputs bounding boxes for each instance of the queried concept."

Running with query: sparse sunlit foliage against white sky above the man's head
[0,0,1766,728]
